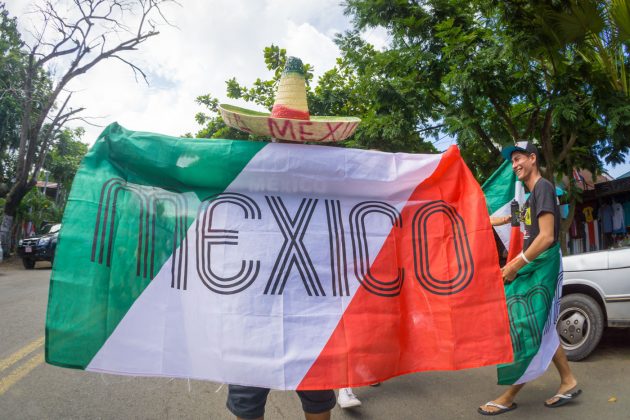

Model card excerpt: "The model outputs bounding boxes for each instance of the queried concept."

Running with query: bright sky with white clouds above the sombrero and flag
[5,0,630,176]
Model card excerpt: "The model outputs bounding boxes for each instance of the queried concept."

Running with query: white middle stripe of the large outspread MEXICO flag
[87,144,441,389]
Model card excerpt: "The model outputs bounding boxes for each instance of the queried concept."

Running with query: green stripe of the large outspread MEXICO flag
[46,123,266,369]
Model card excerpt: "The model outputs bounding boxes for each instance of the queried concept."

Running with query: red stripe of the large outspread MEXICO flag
[298,147,513,390]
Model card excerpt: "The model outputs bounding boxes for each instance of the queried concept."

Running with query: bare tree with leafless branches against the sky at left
[0,0,178,246]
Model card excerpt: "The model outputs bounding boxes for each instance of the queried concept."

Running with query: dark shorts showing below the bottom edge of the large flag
[226,385,337,419]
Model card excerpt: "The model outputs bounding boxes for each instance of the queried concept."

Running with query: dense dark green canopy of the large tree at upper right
[339,0,629,180]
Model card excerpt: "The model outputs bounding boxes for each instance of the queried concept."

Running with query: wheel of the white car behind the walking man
[556,293,604,362]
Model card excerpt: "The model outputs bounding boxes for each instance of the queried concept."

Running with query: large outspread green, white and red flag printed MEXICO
[46,124,512,389]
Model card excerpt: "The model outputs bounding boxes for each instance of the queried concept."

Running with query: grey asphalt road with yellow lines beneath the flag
[0,261,630,420]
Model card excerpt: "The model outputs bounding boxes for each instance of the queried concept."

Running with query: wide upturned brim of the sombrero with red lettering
[219,104,361,142]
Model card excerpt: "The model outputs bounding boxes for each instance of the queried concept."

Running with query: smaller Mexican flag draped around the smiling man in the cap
[482,161,562,385]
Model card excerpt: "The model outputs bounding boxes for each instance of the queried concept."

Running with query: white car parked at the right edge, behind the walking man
[556,247,630,361]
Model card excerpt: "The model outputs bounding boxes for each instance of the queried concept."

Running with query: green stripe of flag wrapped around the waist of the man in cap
[498,244,560,385]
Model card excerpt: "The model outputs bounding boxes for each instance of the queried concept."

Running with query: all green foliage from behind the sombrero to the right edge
[197,0,630,185]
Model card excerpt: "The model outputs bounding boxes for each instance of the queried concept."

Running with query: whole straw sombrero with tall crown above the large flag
[219,57,361,142]
